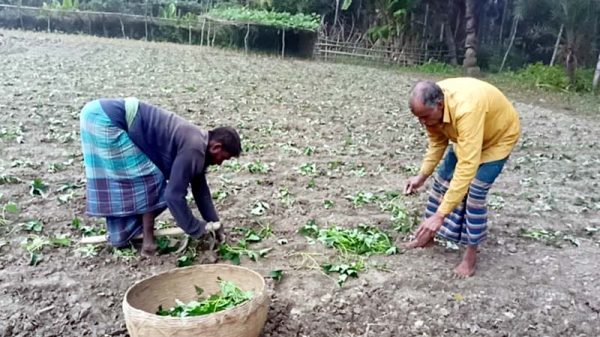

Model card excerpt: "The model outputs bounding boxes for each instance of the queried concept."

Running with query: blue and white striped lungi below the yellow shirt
[425,148,508,246]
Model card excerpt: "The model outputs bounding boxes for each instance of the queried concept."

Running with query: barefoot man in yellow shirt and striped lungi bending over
[405,78,521,277]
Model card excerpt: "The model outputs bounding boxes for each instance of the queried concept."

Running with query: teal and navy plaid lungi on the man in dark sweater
[80,100,166,247]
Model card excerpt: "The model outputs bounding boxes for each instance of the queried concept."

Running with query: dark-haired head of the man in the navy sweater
[206,126,242,165]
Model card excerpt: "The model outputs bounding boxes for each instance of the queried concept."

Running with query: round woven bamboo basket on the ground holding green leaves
[123,264,269,337]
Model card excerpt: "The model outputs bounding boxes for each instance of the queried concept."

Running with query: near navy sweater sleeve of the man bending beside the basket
[165,153,206,238]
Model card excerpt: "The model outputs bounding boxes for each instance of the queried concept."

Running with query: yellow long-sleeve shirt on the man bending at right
[421,78,521,214]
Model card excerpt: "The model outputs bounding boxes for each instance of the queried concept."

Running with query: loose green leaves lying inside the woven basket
[156,279,254,317]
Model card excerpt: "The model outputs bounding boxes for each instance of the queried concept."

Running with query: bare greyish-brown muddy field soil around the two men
[0,30,600,336]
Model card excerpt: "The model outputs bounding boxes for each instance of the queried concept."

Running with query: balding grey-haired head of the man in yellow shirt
[408,81,444,126]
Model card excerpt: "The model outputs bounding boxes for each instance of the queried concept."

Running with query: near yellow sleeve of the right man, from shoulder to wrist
[437,112,485,215]
